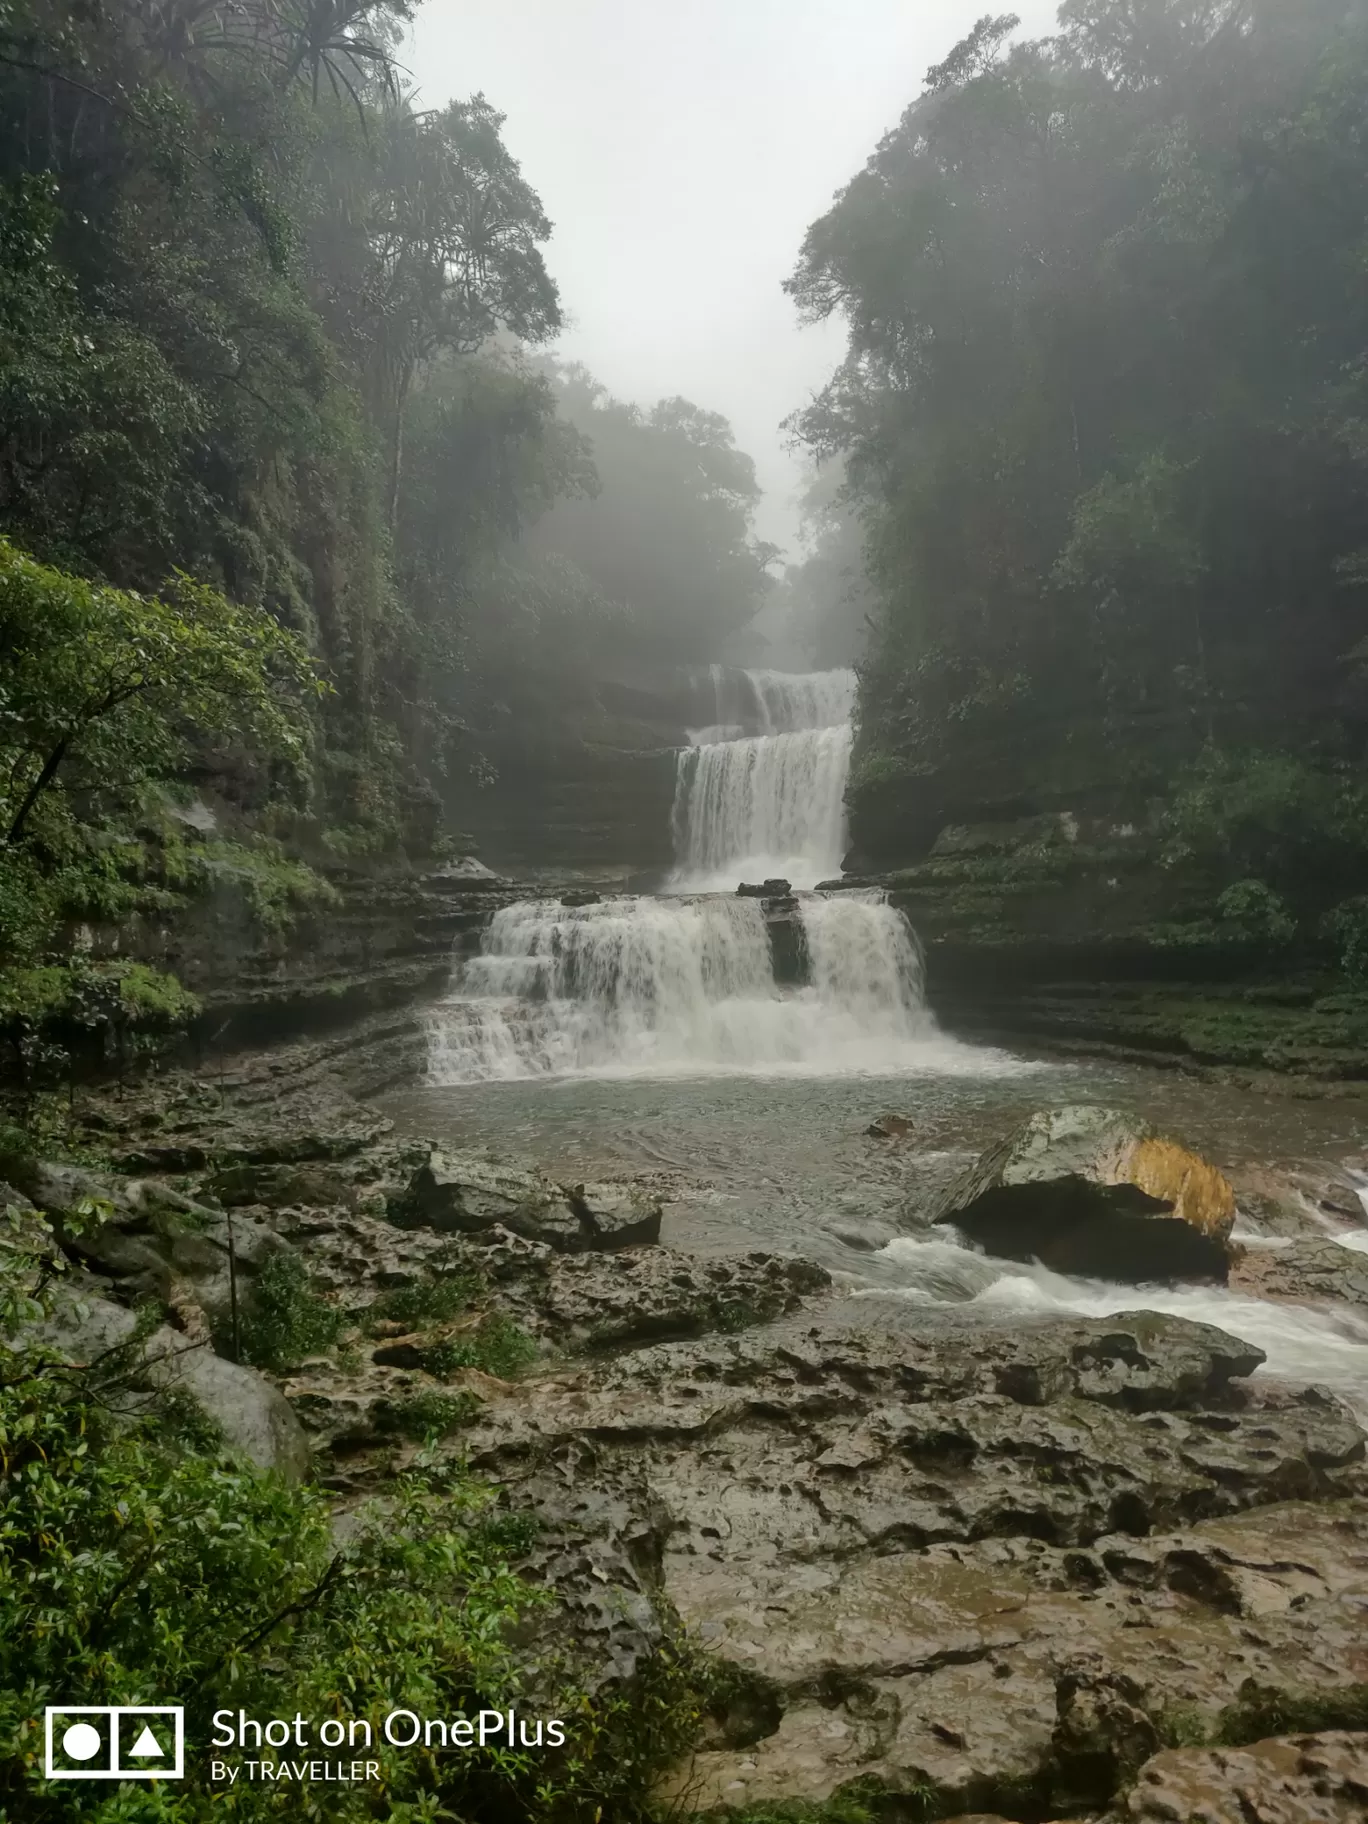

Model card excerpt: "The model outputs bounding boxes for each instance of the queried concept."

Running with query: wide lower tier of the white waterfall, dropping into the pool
[429,894,947,1083]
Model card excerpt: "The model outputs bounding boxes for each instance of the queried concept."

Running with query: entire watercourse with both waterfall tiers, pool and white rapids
[404,669,1368,1412]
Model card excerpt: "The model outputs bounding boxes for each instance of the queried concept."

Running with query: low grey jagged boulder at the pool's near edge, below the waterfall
[390,1151,660,1253]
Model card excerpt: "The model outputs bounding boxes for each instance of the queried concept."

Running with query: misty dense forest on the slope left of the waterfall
[0,0,770,1065]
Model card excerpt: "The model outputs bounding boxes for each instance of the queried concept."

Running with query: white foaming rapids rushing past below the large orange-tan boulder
[870,1235,1368,1417]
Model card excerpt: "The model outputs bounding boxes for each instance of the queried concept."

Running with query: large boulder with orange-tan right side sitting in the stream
[932,1105,1235,1284]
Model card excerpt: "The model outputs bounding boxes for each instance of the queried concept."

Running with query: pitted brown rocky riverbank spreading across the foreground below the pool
[2,1047,1368,1824]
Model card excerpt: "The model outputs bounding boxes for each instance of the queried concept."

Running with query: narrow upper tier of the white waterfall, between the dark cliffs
[671,666,855,892]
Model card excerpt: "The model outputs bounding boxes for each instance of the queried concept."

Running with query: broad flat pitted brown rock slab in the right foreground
[465,1299,1368,1817]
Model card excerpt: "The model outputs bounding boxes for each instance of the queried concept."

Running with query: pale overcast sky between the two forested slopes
[405,0,1056,556]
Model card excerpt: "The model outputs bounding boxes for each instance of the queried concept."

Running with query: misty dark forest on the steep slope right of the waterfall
[790,0,1368,958]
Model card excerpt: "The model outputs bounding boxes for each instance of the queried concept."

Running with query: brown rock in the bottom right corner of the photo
[1122,1729,1368,1824]
